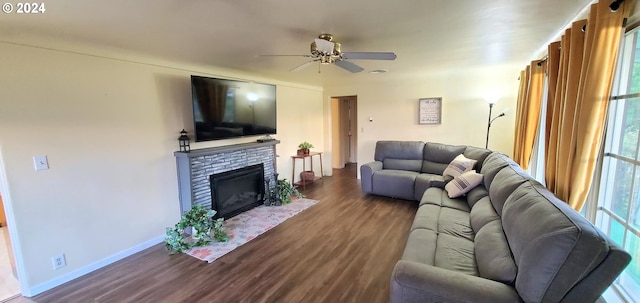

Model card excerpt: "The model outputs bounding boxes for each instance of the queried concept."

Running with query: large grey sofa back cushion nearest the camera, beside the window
[502,180,609,302]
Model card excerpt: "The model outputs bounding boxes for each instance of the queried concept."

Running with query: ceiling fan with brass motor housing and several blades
[262,34,396,73]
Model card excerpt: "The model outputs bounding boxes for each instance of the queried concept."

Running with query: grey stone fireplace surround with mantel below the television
[173,140,280,214]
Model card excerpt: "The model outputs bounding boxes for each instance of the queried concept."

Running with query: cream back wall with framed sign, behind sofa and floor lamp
[324,66,519,177]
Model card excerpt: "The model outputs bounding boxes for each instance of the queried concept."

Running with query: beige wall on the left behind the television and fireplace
[0,43,324,294]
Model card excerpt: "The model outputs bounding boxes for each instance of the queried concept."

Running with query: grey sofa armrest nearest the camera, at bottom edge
[391,260,522,303]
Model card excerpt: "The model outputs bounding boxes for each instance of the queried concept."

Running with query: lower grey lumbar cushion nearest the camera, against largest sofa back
[474,220,518,284]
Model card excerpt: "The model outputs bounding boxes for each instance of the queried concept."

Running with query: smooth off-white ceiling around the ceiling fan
[0,0,592,85]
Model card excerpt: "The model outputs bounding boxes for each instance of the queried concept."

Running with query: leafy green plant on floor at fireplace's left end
[164,205,229,254]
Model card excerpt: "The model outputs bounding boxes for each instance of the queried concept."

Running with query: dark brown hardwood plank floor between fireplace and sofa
[9,164,417,303]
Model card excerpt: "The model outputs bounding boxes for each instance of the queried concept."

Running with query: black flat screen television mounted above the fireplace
[191,75,276,141]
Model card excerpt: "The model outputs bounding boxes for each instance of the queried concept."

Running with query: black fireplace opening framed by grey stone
[209,163,265,220]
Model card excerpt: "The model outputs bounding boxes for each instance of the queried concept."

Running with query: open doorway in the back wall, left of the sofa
[331,96,358,177]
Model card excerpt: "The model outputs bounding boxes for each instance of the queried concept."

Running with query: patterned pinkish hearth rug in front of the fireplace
[186,198,318,263]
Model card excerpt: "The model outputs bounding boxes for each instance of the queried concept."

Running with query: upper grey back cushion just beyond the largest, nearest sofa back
[489,165,531,215]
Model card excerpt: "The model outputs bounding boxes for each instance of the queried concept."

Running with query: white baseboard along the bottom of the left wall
[22,235,165,297]
